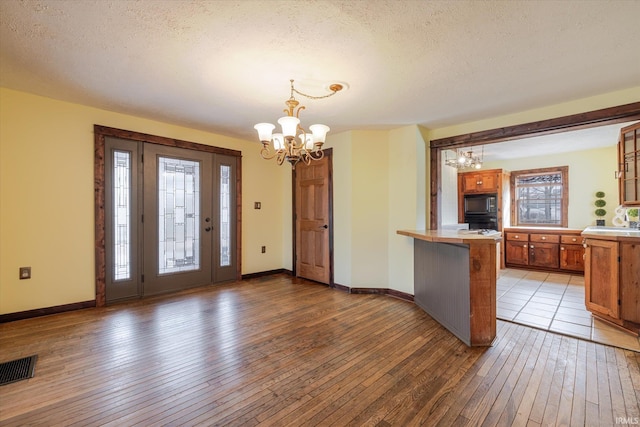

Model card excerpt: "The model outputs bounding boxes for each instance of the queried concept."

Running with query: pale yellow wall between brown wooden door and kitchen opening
[327,126,426,294]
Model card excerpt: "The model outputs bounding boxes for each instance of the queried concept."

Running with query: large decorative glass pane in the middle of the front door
[158,157,200,274]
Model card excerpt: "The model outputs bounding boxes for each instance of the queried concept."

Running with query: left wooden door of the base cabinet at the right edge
[584,239,620,319]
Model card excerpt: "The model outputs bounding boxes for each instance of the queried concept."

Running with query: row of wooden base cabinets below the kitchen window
[505,228,584,273]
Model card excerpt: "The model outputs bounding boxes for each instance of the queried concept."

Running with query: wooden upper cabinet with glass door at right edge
[618,122,640,206]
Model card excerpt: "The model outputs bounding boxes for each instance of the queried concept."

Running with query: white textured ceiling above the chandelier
[0,0,640,159]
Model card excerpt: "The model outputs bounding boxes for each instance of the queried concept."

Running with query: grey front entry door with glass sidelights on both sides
[105,137,237,301]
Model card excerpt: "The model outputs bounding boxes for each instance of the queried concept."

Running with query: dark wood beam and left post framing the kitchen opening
[429,102,640,230]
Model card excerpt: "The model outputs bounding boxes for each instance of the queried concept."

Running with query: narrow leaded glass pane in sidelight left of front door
[113,151,131,280]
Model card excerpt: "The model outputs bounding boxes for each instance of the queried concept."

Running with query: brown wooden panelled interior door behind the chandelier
[294,150,333,285]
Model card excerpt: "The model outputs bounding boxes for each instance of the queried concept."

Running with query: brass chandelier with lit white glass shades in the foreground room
[253,80,343,169]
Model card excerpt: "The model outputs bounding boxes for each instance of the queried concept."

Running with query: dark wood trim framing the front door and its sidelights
[93,125,242,307]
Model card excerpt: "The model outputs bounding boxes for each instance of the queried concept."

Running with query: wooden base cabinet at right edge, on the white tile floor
[583,227,640,335]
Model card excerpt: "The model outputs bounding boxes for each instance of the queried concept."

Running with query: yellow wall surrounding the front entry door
[0,88,284,314]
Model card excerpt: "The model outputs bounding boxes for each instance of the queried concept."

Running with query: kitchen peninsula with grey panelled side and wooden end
[397,230,502,346]
